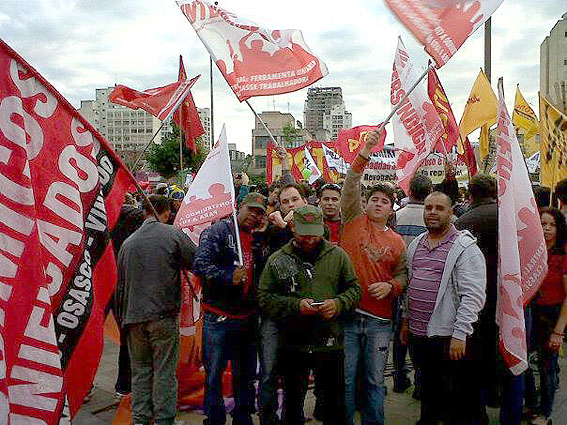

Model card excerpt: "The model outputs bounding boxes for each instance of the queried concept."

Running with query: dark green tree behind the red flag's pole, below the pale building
[146,125,208,179]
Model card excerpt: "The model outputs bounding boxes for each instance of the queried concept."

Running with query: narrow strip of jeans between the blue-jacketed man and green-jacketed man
[258,316,279,425]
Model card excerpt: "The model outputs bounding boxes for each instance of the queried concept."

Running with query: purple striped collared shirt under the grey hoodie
[408,225,459,336]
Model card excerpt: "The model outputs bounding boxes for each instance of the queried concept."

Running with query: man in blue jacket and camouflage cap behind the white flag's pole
[194,192,267,425]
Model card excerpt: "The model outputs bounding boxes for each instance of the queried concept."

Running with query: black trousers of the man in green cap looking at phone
[279,348,345,425]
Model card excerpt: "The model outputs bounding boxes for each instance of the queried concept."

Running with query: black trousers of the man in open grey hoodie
[410,335,482,425]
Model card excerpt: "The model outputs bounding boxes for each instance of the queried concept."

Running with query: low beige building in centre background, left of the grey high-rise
[252,111,313,176]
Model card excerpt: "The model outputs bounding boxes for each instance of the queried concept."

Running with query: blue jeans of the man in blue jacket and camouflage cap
[203,312,256,425]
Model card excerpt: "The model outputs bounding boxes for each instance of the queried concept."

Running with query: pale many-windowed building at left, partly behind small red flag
[78,87,167,164]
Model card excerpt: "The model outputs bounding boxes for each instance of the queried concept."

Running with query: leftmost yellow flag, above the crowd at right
[459,69,498,140]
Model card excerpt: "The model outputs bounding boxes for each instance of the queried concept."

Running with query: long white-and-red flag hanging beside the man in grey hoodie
[496,79,547,375]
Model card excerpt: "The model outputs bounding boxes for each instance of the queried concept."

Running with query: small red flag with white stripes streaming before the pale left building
[108,75,200,121]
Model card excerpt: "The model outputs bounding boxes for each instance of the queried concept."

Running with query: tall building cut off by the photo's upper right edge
[539,13,567,111]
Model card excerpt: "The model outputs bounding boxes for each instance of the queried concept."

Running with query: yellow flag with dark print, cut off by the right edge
[539,93,567,188]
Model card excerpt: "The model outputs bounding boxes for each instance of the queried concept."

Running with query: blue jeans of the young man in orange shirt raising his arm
[345,313,391,425]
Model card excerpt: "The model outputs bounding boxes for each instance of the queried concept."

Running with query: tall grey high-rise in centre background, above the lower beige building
[303,87,343,134]
